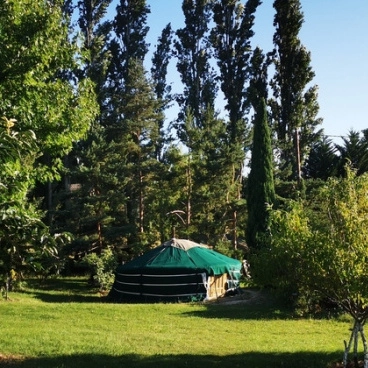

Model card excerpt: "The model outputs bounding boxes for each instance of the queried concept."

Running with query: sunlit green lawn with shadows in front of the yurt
[0,279,351,368]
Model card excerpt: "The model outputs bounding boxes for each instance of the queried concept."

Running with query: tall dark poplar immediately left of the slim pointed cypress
[211,0,261,248]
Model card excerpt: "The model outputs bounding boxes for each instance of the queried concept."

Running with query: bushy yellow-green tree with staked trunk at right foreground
[255,167,368,364]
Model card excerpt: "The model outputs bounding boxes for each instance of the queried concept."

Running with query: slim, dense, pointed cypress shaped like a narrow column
[247,98,275,249]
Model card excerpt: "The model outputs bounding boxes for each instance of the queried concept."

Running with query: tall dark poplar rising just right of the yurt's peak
[174,0,224,242]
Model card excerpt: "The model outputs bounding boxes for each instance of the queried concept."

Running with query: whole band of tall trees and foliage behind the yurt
[0,0,368,304]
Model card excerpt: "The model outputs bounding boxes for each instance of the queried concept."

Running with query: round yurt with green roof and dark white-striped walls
[109,239,242,302]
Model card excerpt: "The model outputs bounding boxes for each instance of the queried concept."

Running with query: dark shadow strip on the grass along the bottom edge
[0,350,340,368]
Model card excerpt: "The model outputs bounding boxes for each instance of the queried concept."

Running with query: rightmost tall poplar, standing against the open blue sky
[270,0,321,182]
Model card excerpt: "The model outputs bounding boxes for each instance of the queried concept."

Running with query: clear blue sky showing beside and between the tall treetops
[115,0,368,141]
